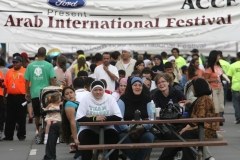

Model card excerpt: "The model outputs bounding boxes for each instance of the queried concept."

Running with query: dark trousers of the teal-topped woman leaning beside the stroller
[43,122,60,160]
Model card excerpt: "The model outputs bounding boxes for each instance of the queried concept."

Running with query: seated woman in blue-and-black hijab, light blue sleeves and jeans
[115,77,154,160]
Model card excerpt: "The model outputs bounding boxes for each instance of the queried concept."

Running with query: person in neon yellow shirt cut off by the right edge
[227,52,240,124]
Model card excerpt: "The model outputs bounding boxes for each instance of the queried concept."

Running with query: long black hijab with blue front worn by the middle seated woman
[120,77,151,120]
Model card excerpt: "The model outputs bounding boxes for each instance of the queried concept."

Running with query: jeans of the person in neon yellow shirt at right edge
[232,90,240,121]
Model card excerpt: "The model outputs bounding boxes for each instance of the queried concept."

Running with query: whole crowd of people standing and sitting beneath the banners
[0,46,240,160]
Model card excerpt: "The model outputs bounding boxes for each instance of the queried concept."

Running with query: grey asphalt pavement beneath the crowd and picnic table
[0,102,240,160]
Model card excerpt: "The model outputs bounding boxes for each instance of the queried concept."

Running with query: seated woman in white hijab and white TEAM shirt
[76,81,122,160]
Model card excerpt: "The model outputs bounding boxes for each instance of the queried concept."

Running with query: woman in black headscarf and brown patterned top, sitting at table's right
[159,78,217,160]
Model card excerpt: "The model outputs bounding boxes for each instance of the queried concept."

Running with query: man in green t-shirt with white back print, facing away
[24,47,56,135]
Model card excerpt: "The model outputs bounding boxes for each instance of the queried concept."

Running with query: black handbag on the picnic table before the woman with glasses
[160,103,182,119]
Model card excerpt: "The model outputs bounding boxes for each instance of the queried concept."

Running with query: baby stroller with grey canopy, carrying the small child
[35,86,62,144]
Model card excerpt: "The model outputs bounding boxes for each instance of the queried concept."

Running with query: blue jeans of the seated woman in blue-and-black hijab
[119,131,154,160]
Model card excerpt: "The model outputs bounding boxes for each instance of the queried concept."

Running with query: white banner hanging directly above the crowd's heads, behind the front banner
[9,42,240,57]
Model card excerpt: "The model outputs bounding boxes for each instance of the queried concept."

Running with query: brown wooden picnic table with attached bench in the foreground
[78,117,228,160]
